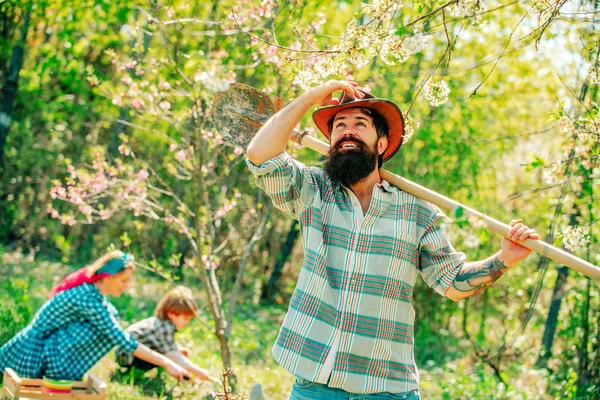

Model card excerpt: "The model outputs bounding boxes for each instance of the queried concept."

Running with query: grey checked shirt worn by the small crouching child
[115,317,177,367]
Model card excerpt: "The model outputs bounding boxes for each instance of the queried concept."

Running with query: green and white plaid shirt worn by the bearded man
[247,152,465,394]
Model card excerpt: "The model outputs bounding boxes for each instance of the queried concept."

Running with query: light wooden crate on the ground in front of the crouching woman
[2,368,108,400]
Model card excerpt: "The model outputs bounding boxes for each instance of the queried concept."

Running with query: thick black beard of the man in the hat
[325,137,377,187]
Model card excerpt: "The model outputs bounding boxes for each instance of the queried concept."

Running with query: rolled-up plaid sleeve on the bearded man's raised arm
[246,152,319,219]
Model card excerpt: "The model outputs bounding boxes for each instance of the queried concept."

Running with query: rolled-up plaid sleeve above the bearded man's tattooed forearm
[419,208,466,296]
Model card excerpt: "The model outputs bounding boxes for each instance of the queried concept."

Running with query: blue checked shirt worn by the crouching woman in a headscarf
[0,284,138,380]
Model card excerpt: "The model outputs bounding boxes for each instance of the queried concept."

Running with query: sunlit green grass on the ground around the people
[0,255,595,400]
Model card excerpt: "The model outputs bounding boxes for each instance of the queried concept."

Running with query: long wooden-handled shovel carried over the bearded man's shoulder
[211,83,600,282]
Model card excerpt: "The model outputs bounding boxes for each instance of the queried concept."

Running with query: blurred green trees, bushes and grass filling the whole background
[0,0,600,398]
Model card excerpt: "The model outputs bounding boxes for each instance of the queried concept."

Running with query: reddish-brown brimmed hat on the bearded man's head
[313,89,404,162]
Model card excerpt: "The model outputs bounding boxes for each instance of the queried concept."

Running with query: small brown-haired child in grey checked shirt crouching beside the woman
[116,286,221,383]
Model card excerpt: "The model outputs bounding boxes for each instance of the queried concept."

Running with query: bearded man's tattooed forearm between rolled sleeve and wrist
[452,257,508,294]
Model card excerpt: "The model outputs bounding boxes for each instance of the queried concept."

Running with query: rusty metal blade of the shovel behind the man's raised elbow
[210,83,283,149]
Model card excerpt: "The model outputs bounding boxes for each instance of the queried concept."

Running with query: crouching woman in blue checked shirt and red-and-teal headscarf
[0,251,188,380]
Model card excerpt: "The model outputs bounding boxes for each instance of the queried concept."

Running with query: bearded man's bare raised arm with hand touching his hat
[247,81,363,165]
